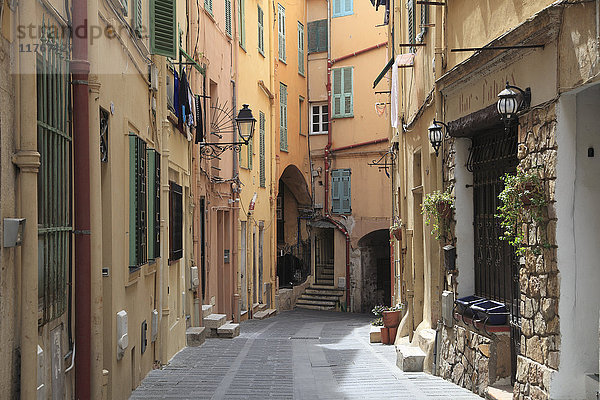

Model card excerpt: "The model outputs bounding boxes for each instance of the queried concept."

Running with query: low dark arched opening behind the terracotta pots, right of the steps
[358,229,393,312]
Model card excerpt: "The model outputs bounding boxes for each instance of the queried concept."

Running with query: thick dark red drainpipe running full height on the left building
[71,1,92,399]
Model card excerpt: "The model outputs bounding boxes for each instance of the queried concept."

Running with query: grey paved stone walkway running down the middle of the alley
[131,310,481,400]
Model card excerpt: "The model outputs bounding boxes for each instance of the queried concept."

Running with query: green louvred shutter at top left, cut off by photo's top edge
[150,0,177,58]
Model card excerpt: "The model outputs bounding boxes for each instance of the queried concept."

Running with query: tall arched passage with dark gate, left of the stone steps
[277,165,312,287]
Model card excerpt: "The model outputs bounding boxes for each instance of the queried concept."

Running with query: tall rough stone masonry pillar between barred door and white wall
[513,103,560,400]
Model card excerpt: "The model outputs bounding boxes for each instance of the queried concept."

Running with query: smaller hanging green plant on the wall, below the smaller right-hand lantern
[421,187,454,240]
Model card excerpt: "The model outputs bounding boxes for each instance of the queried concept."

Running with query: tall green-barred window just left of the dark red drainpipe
[33,29,73,325]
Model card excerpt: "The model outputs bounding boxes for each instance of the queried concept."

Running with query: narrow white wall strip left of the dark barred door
[454,139,475,298]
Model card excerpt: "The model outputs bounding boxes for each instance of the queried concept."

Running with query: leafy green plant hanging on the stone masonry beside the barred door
[496,170,549,255]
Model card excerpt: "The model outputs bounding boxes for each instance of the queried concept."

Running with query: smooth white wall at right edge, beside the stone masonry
[550,85,600,399]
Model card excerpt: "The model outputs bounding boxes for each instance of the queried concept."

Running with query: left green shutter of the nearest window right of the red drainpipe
[129,133,148,269]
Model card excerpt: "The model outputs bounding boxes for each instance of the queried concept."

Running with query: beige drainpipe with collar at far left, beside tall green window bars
[13,1,40,400]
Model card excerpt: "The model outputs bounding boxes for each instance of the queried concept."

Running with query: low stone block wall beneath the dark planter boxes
[438,323,510,396]
